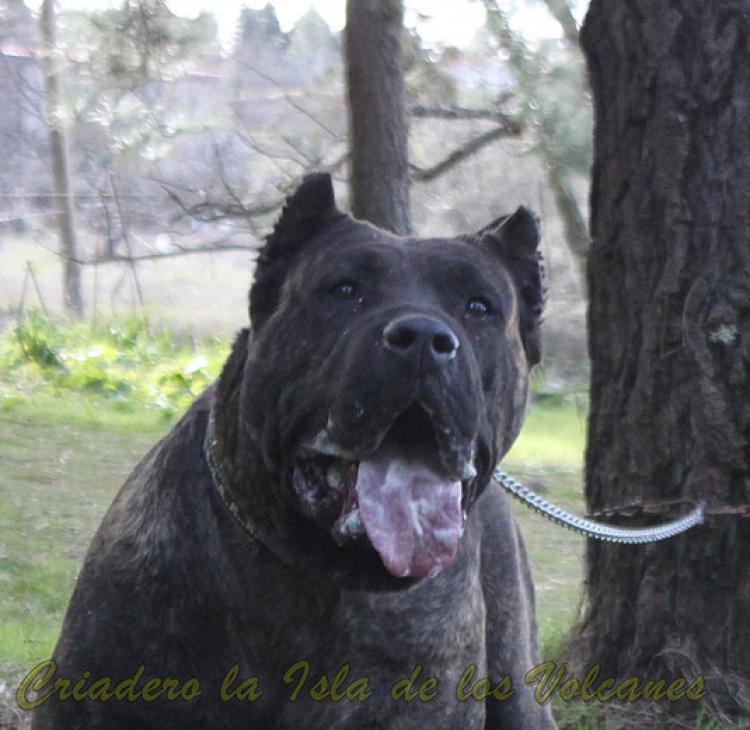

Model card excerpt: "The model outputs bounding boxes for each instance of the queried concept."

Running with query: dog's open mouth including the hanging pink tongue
[293,405,463,578]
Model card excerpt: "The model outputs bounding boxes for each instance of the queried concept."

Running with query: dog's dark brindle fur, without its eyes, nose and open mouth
[33,175,554,730]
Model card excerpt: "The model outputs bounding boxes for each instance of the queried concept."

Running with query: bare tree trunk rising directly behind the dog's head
[346,0,411,235]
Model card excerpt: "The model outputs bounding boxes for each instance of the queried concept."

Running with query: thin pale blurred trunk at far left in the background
[39,0,83,317]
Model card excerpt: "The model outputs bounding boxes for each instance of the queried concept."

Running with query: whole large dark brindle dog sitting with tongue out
[28,174,553,730]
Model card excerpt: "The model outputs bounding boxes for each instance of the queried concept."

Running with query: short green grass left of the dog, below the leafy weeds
[0,393,165,728]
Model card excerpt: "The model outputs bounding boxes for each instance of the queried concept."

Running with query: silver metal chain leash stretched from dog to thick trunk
[493,468,705,545]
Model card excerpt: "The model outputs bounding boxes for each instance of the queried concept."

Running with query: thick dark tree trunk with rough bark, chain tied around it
[578,0,750,727]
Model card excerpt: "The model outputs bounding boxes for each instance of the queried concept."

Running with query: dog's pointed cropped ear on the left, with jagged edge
[250,172,344,328]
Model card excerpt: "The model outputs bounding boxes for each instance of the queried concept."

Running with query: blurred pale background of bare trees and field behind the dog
[0,0,591,384]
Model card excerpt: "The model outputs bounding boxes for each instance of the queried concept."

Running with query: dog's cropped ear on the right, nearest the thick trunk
[475,206,545,365]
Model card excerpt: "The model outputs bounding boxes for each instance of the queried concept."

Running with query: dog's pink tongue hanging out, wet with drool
[357,449,462,578]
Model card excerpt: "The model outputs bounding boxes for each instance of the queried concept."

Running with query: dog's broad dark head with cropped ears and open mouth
[218,174,543,580]
